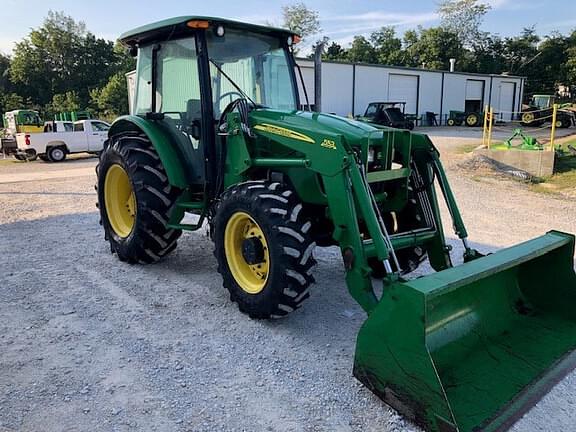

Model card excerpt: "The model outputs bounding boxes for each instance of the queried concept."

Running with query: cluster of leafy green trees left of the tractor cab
[0,11,136,119]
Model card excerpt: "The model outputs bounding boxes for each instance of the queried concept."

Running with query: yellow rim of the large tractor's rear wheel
[104,164,136,238]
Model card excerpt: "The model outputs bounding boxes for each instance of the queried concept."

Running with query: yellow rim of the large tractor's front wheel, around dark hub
[224,212,270,294]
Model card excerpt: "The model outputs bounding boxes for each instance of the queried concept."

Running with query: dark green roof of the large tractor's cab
[118,15,296,46]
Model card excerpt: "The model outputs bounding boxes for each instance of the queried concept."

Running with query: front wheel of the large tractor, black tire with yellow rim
[213,181,316,319]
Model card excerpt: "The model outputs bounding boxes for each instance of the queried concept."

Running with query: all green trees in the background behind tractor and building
[0,0,576,119]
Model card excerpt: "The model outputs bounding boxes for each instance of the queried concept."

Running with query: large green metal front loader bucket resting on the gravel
[354,232,576,432]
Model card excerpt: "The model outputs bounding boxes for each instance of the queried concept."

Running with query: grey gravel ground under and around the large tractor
[0,135,576,432]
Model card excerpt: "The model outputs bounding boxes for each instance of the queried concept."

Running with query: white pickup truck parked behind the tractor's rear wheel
[14,120,110,162]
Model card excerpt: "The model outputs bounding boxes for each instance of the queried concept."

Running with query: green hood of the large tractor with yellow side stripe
[250,109,383,146]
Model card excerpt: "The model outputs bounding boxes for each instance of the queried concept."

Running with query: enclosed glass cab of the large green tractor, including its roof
[120,16,299,190]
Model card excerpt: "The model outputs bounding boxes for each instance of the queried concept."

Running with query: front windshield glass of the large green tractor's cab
[206,30,296,117]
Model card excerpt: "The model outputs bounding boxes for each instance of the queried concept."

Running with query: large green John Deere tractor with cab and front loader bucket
[97,16,576,432]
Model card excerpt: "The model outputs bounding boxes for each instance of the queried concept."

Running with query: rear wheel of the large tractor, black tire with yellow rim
[96,136,182,264]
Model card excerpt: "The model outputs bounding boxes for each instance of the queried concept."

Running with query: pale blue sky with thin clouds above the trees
[0,0,576,54]
